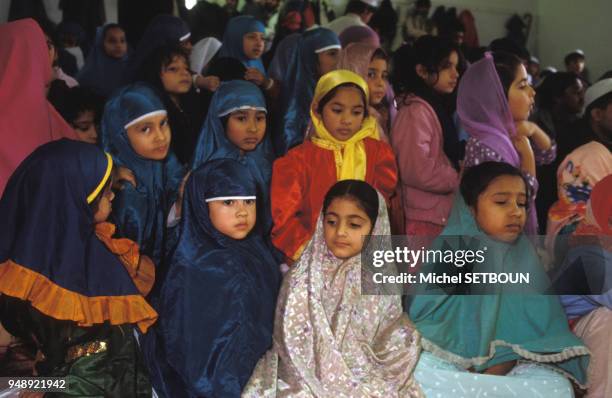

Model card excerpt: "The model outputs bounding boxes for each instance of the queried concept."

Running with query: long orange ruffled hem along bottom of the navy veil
[0,260,157,333]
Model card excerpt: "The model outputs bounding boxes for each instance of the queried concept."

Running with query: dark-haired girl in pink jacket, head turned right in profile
[391,36,461,239]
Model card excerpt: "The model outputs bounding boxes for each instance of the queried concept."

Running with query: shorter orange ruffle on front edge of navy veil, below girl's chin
[96,222,155,296]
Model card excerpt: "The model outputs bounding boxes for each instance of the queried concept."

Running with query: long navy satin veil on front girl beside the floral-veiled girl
[141,159,280,398]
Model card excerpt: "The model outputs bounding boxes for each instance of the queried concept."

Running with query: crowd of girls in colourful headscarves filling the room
[0,4,612,398]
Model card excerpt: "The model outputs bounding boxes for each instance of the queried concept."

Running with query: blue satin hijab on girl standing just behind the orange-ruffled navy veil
[101,83,185,275]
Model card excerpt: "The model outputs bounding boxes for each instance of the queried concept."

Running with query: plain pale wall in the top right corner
[537,0,612,81]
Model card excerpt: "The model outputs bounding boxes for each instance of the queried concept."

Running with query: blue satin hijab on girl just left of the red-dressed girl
[192,80,273,231]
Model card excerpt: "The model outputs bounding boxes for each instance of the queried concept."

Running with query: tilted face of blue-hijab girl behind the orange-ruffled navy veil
[127,115,171,160]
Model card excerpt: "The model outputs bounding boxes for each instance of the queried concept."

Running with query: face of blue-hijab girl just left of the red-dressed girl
[226,109,266,152]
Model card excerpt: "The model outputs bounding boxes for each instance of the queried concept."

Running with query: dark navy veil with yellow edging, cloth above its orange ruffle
[0,139,140,297]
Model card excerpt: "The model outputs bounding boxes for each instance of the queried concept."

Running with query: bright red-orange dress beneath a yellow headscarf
[270,138,397,260]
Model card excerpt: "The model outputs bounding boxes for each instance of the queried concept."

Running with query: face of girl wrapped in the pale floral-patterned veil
[323,197,372,260]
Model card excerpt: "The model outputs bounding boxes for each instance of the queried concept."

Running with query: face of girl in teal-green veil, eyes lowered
[472,175,527,243]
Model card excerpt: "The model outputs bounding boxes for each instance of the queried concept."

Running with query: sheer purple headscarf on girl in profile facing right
[457,52,520,167]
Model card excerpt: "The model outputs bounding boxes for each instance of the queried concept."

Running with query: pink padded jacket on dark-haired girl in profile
[391,95,459,226]
